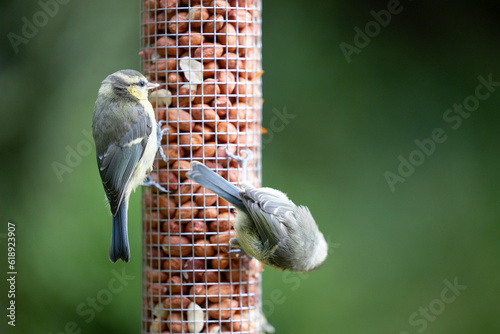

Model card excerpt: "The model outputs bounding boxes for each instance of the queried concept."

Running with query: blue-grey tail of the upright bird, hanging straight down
[109,201,130,263]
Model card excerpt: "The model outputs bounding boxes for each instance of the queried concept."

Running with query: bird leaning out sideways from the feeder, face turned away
[186,161,328,272]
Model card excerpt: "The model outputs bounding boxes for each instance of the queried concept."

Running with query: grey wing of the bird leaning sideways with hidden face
[241,188,295,248]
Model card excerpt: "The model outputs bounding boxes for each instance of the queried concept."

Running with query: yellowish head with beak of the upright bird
[99,70,159,101]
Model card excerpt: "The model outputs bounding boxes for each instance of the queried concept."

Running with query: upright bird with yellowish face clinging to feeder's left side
[92,70,158,263]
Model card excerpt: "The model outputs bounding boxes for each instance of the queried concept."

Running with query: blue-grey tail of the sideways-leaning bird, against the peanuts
[186,161,246,211]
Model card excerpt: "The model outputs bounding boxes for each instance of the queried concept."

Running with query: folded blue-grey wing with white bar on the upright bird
[97,105,152,215]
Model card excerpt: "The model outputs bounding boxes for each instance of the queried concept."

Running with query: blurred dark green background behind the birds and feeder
[0,0,500,334]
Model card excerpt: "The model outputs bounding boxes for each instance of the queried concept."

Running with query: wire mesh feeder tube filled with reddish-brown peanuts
[140,0,264,333]
